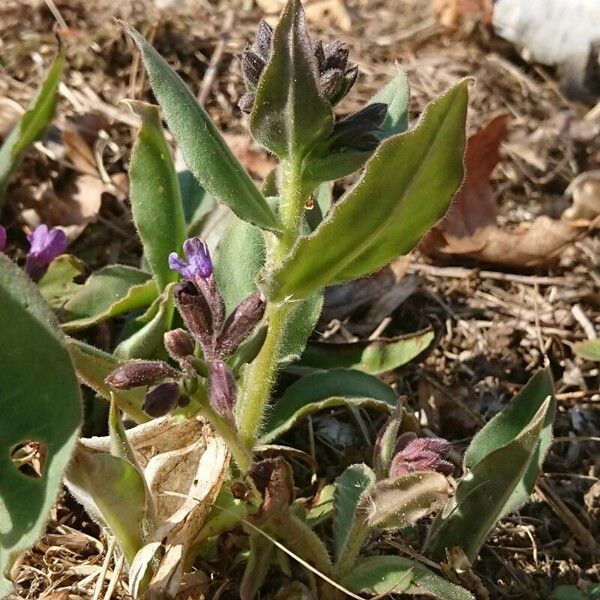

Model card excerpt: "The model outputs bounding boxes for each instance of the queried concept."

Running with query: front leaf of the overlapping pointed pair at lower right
[427,397,553,561]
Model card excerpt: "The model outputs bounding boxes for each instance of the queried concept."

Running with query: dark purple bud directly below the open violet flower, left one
[174,281,214,360]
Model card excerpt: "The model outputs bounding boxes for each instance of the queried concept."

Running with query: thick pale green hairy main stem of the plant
[237,160,307,449]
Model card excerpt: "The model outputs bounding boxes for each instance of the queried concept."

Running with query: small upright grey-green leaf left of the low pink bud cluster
[333,464,376,566]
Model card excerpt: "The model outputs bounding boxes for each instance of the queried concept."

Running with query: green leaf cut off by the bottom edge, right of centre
[341,555,475,600]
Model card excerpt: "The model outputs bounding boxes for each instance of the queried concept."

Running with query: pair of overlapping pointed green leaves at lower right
[428,371,556,560]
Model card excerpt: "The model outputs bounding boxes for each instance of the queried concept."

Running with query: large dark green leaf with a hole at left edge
[0,255,81,597]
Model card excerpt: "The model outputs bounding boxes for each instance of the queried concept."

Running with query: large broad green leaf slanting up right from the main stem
[265,80,468,302]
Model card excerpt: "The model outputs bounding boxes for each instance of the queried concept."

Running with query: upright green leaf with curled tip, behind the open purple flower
[127,100,186,291]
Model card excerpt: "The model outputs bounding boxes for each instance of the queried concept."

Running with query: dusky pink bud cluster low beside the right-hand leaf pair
[390,432,454,478]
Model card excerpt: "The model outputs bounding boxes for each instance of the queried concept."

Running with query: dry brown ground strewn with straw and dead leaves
[0,0,600,600]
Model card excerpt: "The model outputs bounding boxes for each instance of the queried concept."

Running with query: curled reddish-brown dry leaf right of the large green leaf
[422,115,579,267]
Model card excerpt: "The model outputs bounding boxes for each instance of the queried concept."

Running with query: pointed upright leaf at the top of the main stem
[250,0,333,159]
